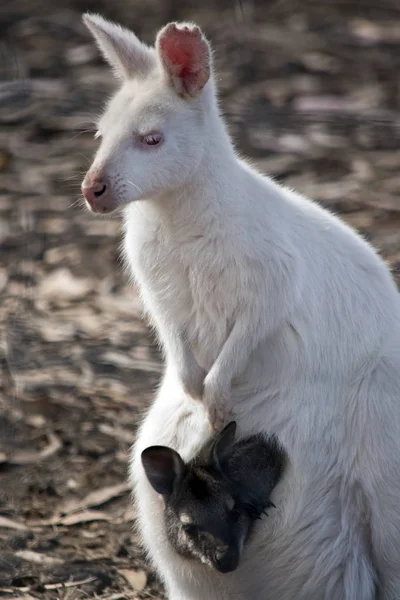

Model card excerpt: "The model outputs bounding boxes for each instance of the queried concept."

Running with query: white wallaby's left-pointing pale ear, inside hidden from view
[82,13,155,79]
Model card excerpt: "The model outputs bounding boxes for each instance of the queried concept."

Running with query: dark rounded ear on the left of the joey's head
[142,446,186,496]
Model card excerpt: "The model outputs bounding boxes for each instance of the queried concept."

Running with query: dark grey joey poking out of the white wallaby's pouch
[142,422,286,573]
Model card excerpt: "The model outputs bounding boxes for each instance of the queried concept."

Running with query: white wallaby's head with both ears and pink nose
[82,14,214,213]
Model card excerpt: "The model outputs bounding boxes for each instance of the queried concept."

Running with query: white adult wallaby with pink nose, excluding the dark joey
[82,15,400,600]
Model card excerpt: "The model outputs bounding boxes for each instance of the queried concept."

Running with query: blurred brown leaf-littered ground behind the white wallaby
[0,0,400,600]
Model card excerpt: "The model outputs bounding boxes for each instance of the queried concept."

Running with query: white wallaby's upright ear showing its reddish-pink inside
[156,23,211,98]
